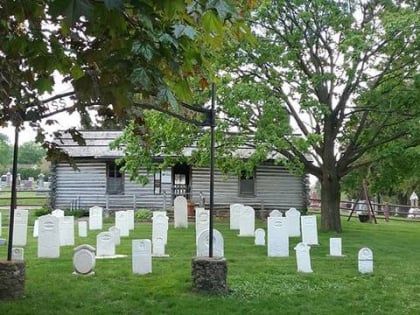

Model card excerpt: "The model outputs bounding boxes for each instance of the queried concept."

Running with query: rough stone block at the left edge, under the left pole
[0,260,25,300]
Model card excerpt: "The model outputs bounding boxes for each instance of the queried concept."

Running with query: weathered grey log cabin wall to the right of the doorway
[192,165,306,210]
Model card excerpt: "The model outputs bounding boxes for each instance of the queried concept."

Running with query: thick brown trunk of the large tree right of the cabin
[321,167,342,233]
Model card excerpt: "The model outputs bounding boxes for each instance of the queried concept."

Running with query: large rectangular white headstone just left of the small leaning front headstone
[267,217,289,257]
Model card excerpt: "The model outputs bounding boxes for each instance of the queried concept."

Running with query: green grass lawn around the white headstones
[0,211,420,315]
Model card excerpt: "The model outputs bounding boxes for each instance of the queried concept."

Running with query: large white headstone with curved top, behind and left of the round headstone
[38,215,60,258]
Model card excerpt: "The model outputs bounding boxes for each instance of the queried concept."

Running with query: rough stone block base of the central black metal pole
[192,257,228,294]
